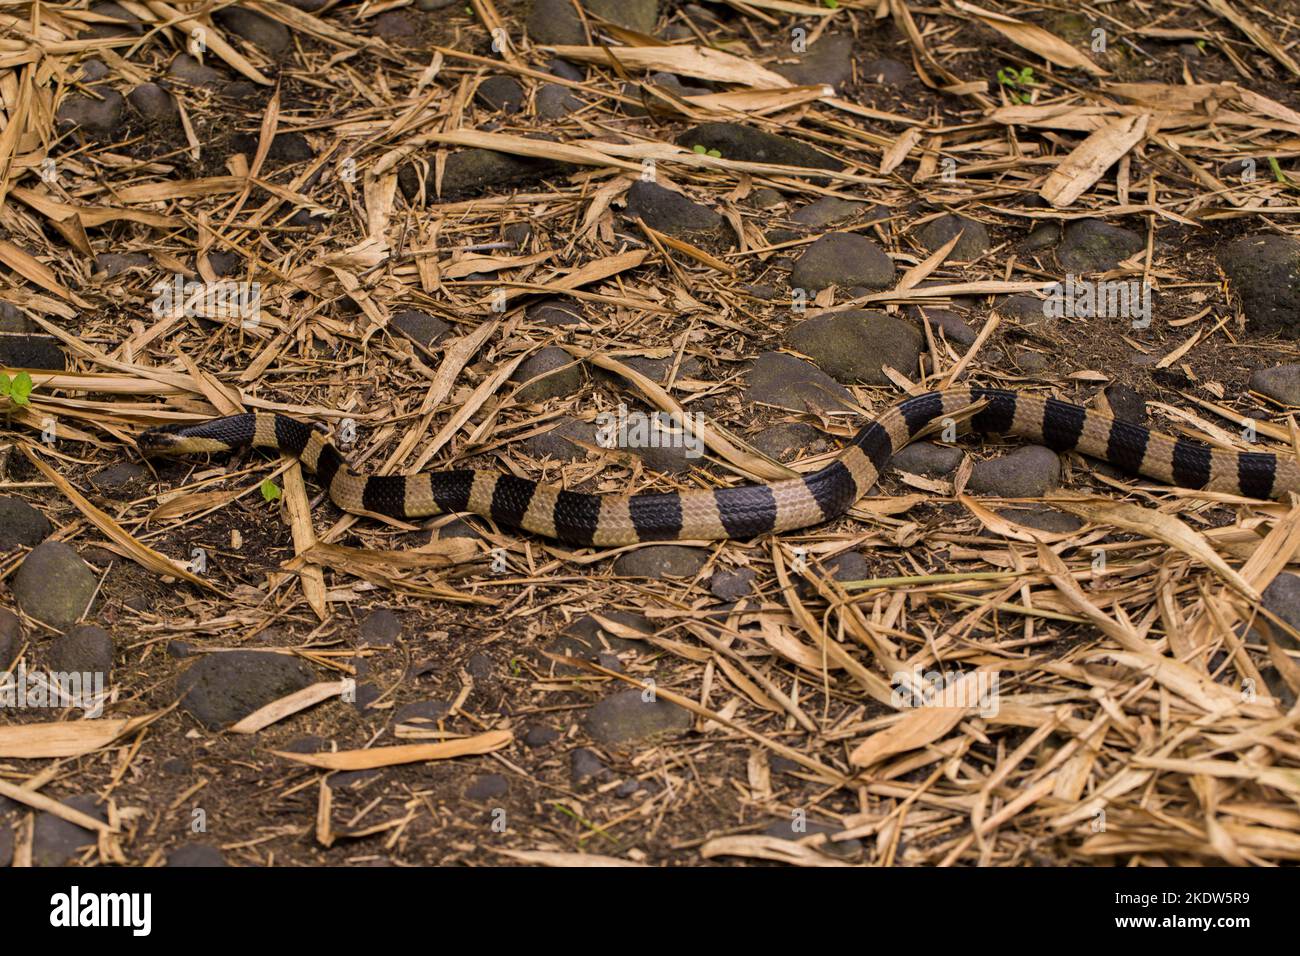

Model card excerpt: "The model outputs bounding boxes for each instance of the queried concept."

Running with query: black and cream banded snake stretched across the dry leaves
[139,386,1300,546]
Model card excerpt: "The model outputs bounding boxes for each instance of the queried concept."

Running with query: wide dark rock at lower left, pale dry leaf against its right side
[177,650,315,730]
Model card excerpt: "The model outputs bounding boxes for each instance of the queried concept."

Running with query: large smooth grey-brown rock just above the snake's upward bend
[787,308,923,385]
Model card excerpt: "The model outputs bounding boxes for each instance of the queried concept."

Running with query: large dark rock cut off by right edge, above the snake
[1218,235,1300,338]
